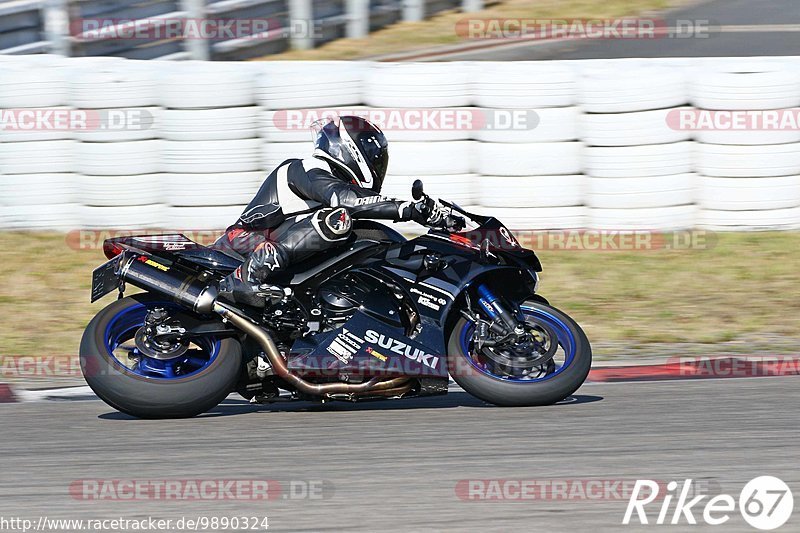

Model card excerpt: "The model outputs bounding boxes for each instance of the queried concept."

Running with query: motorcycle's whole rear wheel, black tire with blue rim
[80,294,242,418]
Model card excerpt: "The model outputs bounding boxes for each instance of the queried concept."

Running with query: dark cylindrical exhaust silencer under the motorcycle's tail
[119,252,219,314]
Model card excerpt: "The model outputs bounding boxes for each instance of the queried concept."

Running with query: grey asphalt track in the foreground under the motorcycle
[0,377,800,533]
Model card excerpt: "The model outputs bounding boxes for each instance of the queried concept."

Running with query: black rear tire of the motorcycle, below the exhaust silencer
[80,294,242,418]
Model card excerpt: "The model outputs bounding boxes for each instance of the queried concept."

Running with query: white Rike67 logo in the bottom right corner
[622,476,794,531]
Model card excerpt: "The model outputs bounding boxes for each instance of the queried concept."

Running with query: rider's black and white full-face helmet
[311,116,389,193]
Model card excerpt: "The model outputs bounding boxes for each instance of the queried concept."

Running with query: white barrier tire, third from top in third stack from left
[162,139,261,174]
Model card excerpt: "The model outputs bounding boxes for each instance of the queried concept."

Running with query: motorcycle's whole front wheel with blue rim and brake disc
[448,301,592,407]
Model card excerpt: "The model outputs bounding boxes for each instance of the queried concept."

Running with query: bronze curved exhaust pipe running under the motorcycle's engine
[213,302,409,396]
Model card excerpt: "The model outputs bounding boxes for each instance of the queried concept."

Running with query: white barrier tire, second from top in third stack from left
[161,106,259,141]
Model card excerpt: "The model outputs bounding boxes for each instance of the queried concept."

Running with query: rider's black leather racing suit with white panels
[215,158,414,283]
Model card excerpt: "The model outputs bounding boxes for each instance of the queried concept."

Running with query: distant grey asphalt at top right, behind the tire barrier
[438,0,800,61]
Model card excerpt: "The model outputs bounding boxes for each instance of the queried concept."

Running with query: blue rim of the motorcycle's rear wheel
[105,302,220,380]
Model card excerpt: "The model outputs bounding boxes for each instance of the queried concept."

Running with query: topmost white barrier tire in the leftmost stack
[0,65,68,109]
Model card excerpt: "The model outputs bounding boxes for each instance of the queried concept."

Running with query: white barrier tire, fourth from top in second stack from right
[586,174,697,209]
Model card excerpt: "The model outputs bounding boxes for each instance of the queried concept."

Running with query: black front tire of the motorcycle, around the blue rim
[447,301,592,407]
